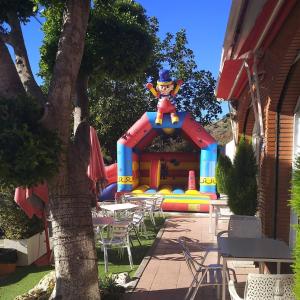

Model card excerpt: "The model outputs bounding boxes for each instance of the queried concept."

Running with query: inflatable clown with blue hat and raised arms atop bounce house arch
[146,70,183,125]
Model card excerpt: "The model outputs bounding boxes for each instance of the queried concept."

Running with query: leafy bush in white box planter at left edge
[0,188,46,266]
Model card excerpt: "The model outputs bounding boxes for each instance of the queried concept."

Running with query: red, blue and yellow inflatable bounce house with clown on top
[102,70,217,212]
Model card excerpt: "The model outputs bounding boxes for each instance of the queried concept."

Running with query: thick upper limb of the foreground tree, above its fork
[45,0,90,142]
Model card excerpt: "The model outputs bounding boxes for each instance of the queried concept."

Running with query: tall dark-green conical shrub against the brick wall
[227,137,257,216]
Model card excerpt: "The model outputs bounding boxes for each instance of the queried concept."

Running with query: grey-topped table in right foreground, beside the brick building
[218,237,293,300]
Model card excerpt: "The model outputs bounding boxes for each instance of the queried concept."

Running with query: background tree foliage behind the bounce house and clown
[90,29,221,160]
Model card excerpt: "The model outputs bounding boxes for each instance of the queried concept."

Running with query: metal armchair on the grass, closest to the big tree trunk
[98,222,133,273]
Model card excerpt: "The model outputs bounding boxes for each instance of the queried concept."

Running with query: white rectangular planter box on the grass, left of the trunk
[0,231,47,266]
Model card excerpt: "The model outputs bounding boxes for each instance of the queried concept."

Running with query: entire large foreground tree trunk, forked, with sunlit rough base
[44,0,100,300]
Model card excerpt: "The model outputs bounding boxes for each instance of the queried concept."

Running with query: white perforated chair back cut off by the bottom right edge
[228,274,296,300]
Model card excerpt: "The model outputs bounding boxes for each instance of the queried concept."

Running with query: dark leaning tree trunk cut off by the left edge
[0,39,25,98]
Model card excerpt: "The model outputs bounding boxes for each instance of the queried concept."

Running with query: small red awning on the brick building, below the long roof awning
[216,59,247,100]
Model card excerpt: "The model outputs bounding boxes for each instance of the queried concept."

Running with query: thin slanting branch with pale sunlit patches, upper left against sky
[8,13,46,104]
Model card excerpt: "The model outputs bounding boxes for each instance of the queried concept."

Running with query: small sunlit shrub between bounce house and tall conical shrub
[216,154,232,194]
